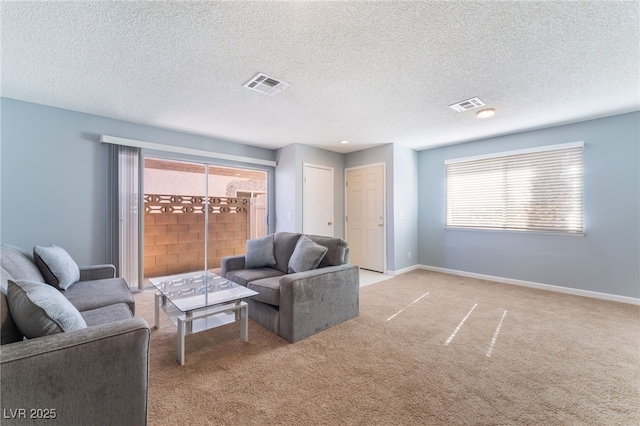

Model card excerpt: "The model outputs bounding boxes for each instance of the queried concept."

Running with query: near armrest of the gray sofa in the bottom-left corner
[0,318,150,425]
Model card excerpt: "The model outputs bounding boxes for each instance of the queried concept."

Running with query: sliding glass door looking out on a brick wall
[143,157,267,278]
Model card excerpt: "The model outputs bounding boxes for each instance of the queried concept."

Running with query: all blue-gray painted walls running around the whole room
[0,98,640,298]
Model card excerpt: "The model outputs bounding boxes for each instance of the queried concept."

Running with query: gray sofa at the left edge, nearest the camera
[0,246,150,426]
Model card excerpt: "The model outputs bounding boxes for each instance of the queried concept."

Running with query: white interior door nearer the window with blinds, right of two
[346,164,386,272]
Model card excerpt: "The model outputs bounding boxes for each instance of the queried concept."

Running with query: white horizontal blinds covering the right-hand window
[445,142,584,234]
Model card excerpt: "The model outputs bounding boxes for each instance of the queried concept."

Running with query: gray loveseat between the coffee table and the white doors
[220,232,360,343]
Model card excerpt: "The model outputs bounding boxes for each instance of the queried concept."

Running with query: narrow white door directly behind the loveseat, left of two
[302,164,333,237]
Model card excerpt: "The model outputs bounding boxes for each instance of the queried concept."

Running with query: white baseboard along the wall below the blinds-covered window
[410,265,640,305]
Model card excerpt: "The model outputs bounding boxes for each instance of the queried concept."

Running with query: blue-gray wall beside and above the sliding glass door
[0,98,276,265]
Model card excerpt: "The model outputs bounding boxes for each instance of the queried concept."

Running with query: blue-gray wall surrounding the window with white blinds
[418,112,640,298]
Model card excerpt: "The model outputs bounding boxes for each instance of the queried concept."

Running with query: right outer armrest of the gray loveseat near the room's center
[280,264,360,343]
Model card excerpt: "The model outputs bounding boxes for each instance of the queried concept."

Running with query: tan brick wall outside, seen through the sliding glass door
[144,195,249,278]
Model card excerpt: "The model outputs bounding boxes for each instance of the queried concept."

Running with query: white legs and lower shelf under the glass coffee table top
[154,293,249,365]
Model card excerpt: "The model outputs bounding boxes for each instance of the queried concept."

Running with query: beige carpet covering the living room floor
[136,271,640,426]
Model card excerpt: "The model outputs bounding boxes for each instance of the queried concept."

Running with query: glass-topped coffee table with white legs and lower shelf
[149,271,258,365]
